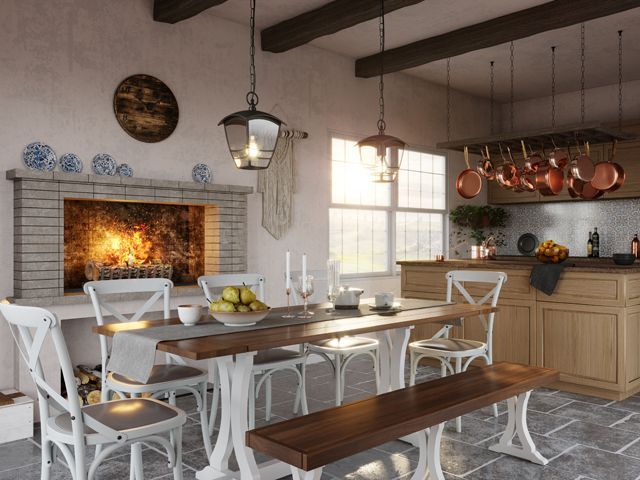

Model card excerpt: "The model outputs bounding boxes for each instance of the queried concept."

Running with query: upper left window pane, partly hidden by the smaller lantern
[331,138,391,207]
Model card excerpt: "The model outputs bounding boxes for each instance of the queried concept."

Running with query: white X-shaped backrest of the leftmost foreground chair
[0,304,84,444]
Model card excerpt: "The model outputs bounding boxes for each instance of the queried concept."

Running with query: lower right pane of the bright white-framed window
[396,212,444,260]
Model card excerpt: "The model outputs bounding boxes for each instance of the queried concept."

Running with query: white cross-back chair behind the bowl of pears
[198,273,309,432]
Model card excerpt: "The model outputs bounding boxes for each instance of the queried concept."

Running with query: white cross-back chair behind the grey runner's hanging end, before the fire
[84,278,211,464]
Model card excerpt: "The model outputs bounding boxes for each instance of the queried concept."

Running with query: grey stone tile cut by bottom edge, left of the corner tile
[464,456,576,480]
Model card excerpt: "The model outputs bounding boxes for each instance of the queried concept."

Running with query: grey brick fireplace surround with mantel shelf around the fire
[6,169,253,305]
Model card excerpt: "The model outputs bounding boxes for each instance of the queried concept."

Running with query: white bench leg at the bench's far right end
[489,391,549,465]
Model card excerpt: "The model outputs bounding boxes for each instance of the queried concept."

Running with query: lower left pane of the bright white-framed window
[329,208,389,274]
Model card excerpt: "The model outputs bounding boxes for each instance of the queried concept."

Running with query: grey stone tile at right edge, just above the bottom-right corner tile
[549,421,638,452]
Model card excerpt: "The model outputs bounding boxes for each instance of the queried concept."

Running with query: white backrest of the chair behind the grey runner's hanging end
[84,278,173,372]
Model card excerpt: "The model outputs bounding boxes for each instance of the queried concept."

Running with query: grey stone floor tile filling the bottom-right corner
[550,445,640,480]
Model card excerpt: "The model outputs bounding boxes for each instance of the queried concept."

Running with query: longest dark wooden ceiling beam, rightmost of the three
[356,0,640,78]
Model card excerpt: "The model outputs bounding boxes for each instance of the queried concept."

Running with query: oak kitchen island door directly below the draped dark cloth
[536,301,624,389]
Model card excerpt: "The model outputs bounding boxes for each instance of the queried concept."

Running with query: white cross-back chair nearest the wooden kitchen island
[409,270,507,432]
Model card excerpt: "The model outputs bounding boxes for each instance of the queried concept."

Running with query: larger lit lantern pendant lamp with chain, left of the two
[218,0,283,170]
